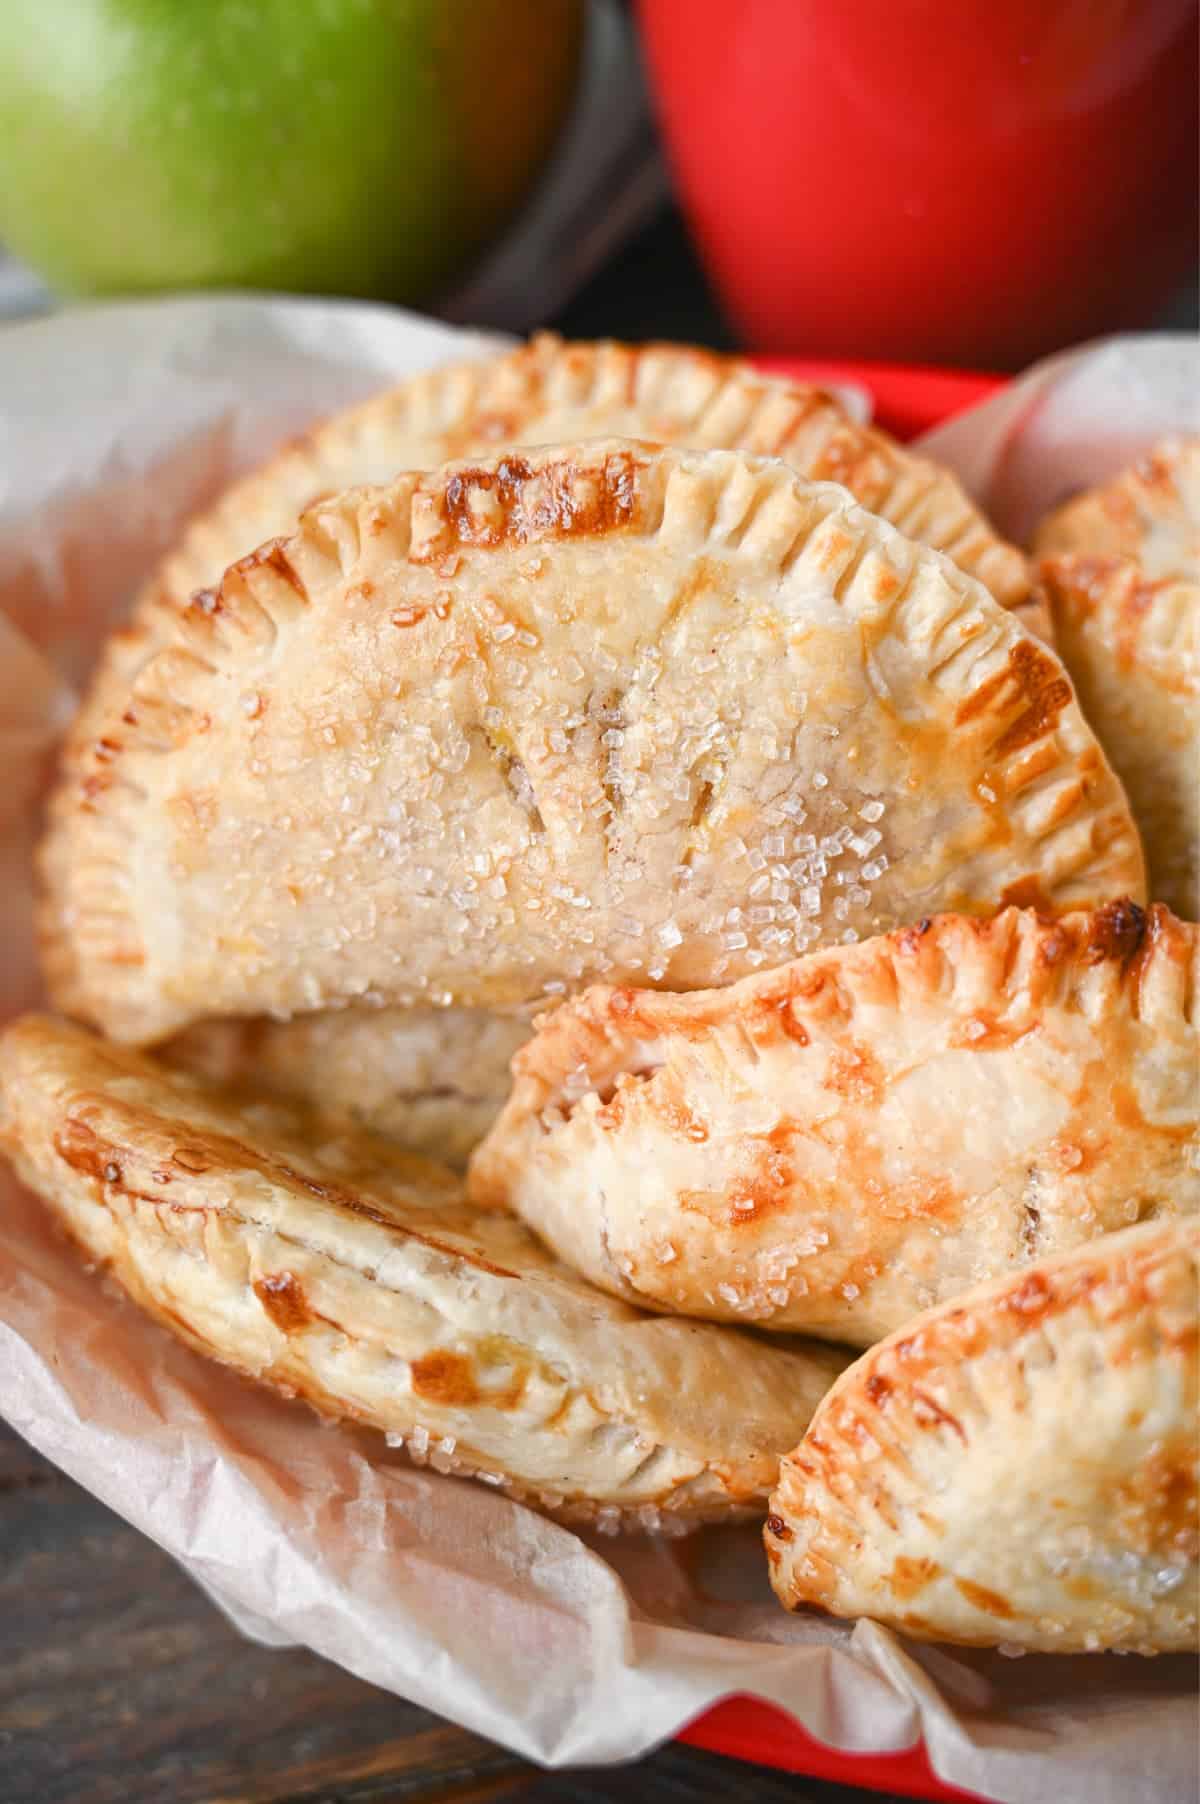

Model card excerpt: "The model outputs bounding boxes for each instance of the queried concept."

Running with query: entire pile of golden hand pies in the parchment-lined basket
[0,339,1200,1652]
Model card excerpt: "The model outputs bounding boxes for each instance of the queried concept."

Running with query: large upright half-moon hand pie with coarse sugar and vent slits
[43,442,1142,1041]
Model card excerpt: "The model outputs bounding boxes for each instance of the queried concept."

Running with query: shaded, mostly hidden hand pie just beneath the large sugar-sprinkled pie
[159,1008,531,1167]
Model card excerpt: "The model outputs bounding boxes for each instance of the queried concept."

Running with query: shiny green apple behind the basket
[0,0,583,301]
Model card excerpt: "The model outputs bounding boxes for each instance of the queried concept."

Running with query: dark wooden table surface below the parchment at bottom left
[0,1425,909,1804]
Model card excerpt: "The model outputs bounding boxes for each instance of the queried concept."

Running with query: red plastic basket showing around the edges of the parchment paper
[678,357,1003,1804]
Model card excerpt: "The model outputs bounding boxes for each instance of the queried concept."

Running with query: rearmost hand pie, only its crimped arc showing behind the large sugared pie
[69,334,1048,756]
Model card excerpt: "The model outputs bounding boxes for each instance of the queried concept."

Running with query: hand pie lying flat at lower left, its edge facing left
[0,1016,845,1528]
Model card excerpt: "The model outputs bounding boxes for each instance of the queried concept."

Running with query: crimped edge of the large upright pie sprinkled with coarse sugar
[42,440,1142,1039]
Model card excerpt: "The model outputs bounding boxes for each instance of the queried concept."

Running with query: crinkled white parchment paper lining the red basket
[0,298,1200,1804]
